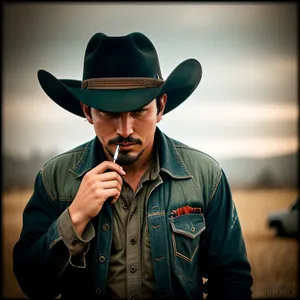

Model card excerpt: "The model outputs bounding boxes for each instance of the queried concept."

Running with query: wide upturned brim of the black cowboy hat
[38,59,202,117]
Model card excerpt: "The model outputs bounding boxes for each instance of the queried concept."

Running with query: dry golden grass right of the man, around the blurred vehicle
[233,190,298,298]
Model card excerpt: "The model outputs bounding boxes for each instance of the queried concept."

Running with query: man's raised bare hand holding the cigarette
[69,161,126,236]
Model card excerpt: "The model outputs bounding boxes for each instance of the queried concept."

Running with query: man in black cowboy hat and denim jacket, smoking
[13,33,252,300]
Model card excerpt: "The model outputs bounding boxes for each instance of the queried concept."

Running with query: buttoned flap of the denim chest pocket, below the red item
[169,213,205,239]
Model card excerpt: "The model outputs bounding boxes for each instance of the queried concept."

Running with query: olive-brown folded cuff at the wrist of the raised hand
[58,208,95,257]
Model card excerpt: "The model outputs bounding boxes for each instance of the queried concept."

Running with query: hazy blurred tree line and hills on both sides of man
[2,151,298,191]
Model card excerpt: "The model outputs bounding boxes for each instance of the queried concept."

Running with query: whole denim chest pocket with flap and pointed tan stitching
[169,213,205,279]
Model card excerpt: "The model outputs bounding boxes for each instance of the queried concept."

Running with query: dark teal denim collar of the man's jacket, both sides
[70,127,192,179]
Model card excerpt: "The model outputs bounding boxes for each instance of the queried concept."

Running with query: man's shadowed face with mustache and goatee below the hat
[82,95,166,165]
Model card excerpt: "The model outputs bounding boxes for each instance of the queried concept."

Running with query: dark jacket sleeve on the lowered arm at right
[200,171,253,300]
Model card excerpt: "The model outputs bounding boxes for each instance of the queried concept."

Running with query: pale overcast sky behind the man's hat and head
[2,2,298,159]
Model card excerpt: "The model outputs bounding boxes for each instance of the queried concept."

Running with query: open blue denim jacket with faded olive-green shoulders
[13,128,253,300]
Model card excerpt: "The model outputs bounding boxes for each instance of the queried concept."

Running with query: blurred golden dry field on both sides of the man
[2,190,298,298]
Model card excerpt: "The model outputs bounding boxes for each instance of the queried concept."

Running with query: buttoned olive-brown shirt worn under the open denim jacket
[106,153,159,299]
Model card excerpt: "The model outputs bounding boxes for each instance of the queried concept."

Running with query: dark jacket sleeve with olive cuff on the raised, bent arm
[13,172,94,299]
